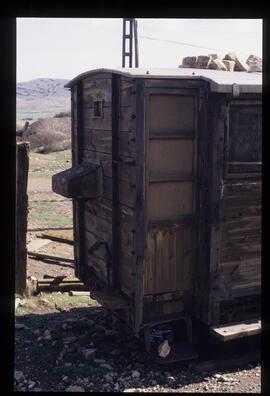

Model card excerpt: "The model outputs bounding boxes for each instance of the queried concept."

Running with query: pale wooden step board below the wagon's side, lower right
[210,319,261,342]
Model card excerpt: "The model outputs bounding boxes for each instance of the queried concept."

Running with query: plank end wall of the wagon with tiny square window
[73,74,136,295]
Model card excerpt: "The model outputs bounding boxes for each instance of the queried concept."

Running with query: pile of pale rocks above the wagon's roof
[179,52,262,72]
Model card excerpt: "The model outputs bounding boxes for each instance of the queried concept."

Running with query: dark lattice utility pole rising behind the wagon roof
[122,18,139,67]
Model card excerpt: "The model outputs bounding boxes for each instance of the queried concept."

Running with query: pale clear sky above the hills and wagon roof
[17,18,262,82]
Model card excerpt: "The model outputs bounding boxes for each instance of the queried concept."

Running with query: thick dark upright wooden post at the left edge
[15,142,29,294]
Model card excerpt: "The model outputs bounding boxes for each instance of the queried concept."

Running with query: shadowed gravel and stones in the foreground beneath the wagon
[14,293,261,393]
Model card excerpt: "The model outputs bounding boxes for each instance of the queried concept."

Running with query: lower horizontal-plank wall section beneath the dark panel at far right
[220,178,261,297]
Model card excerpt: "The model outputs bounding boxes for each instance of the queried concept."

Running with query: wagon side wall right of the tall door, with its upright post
[208,95,261,324]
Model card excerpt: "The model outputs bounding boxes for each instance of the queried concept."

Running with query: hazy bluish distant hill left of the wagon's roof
[16,78,71,122]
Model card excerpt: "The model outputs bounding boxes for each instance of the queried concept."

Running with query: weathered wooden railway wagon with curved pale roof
[52,68,262,356]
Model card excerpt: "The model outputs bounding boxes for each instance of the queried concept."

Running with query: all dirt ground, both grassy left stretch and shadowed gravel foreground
[14,151,261,393]
